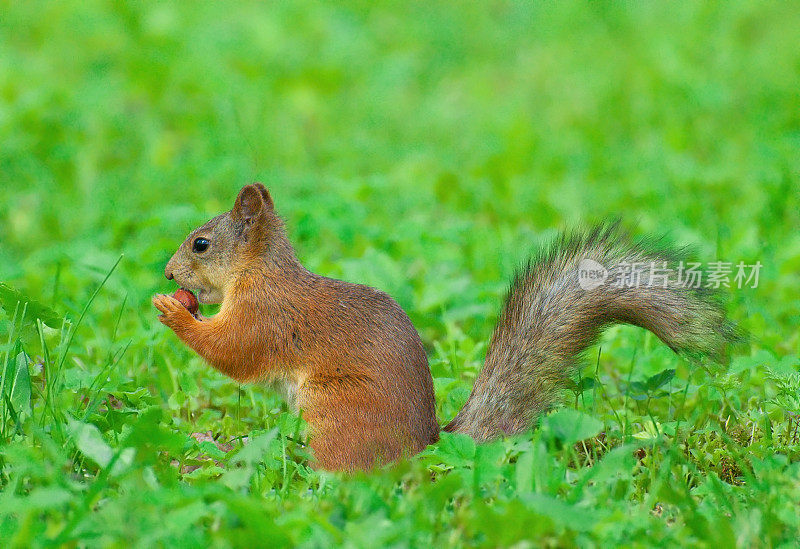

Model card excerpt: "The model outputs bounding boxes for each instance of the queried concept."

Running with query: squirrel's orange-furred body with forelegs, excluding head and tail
[153,199,439,470]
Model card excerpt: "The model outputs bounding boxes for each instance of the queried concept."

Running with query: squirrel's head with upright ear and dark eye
[164,183,294,303]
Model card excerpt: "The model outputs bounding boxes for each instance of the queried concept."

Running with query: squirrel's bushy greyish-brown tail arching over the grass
[445,223,738,441]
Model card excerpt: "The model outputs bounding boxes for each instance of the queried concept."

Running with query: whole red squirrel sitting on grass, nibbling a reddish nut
[152,183,737,471]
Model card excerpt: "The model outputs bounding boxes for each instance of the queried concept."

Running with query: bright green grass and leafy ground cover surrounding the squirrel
[0,1,800,547]
